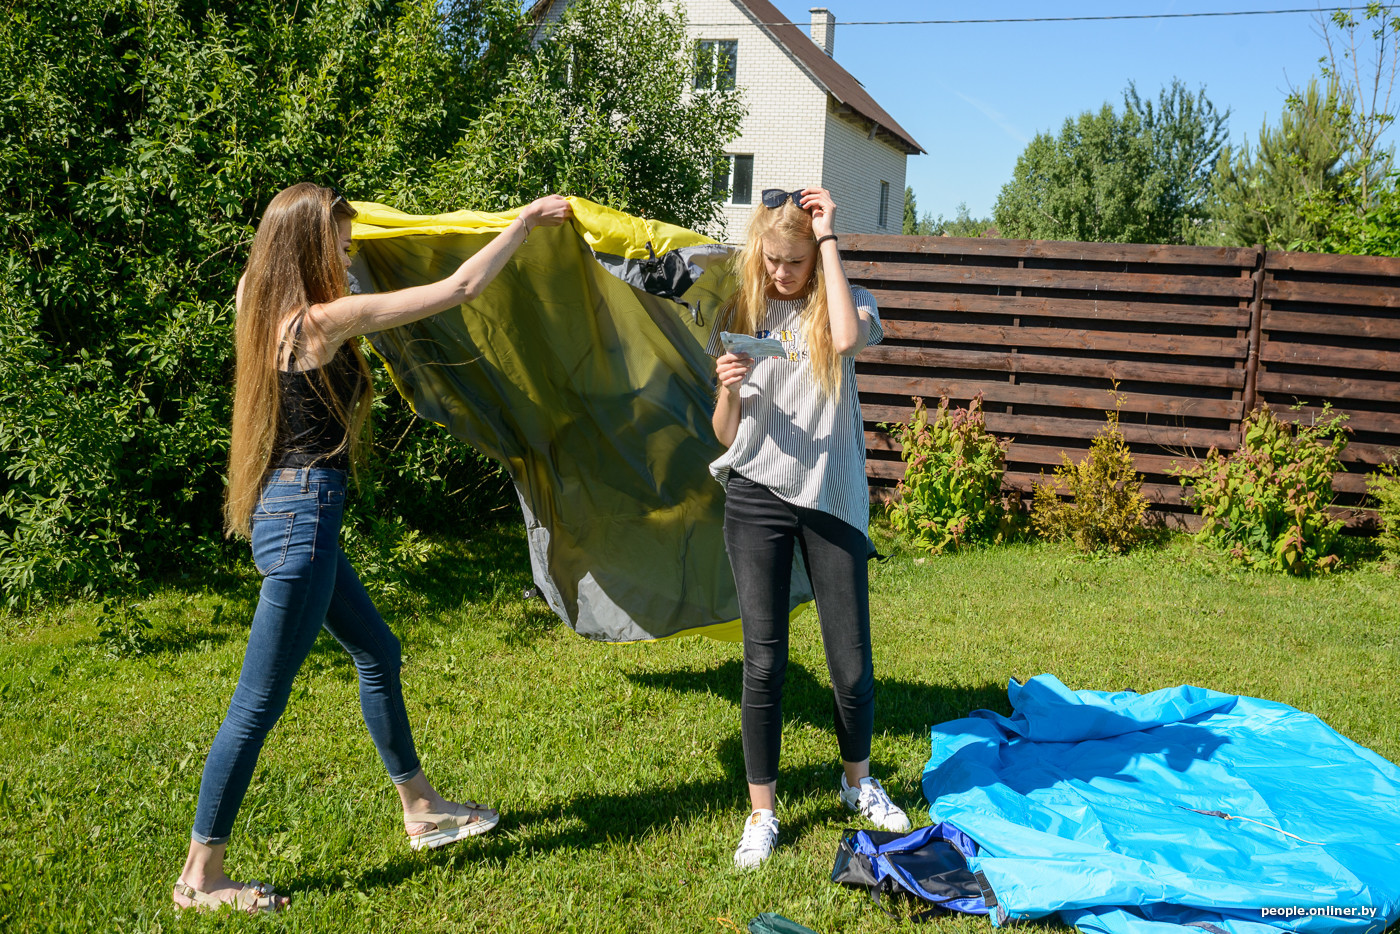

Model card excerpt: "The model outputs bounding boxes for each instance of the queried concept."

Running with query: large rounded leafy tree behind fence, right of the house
[993,81,1229,244]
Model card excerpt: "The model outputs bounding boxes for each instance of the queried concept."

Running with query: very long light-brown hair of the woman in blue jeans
[224,182,371,538]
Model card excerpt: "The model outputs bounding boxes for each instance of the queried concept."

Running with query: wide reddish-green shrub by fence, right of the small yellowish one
[1176,406,1348,574]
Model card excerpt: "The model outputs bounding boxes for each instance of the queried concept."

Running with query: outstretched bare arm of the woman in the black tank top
[308,195,573,346]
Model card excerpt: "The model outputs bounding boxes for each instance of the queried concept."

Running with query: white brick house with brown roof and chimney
[531,0,924,241]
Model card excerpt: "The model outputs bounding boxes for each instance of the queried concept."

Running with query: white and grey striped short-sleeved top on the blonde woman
[706,286,885,532]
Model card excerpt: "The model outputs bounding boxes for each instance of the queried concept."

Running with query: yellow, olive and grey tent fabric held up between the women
[351,199,811,641]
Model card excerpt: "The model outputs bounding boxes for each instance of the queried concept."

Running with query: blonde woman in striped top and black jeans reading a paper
[708,188,909,868]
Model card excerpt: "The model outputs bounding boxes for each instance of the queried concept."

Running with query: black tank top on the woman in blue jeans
[269,330,364,471]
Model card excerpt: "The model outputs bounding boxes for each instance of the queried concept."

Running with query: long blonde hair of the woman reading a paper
[728,200,843,396]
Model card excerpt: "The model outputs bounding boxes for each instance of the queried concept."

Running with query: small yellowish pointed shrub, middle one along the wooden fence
[1030,409,1148,553]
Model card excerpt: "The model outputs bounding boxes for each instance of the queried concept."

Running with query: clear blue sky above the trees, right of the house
[756,0,1377,217]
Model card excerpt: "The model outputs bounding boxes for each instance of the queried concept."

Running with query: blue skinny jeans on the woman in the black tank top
[190,468,419,844]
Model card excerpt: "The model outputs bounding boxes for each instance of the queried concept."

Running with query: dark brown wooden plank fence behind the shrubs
[841,234,1400,525]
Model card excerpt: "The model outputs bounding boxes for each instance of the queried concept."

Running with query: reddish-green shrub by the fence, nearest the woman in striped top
[882,395,1011,555]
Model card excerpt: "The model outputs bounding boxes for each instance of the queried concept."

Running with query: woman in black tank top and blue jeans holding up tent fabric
[174,182,571,912]
